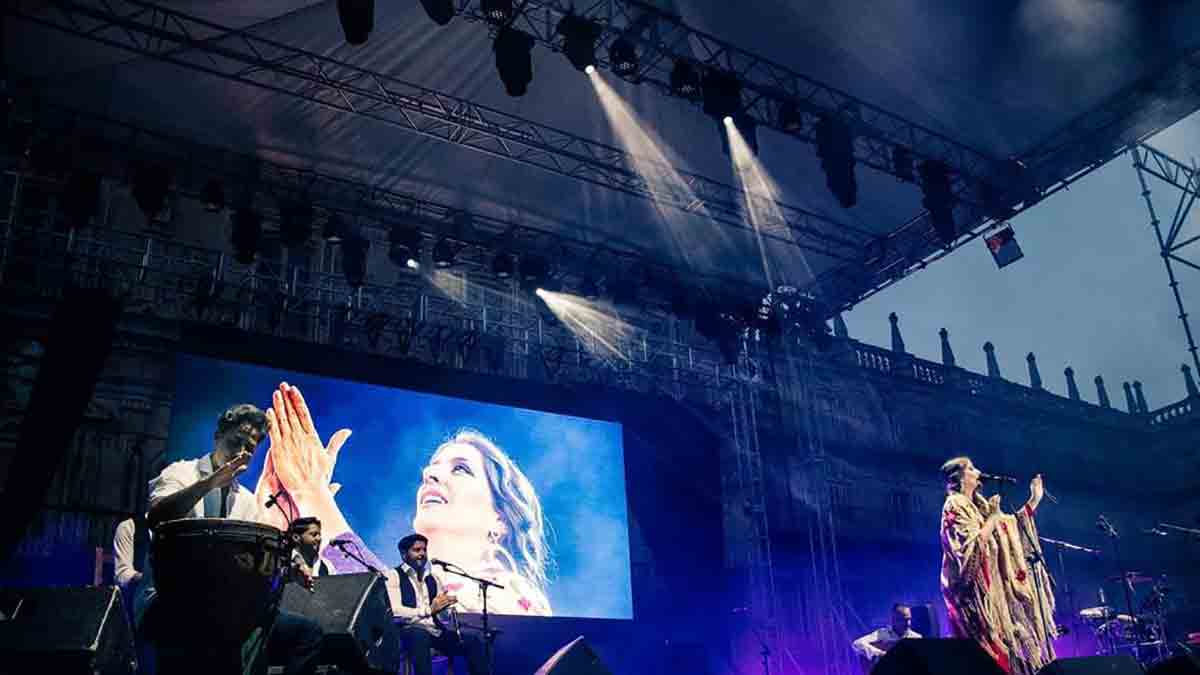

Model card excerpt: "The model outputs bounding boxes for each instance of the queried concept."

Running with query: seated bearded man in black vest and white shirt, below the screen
[392,534,487,675]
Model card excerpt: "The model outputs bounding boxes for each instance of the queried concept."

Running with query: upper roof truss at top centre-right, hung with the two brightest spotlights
[455,0,995,186]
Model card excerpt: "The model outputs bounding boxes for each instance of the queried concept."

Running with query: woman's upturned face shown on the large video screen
[413,443,499,538]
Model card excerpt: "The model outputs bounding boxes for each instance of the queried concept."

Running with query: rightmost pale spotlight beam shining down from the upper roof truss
[721,118,814,288]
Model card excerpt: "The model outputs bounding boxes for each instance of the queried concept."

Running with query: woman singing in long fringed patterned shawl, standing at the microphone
[941,458,1056,675]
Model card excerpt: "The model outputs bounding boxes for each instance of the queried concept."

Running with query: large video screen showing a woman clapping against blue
[167,354,632,619]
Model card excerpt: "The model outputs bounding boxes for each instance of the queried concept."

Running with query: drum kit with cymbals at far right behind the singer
[1079,572,1171,667]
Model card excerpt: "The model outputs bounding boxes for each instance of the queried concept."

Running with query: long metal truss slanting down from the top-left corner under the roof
[6,0,874,263]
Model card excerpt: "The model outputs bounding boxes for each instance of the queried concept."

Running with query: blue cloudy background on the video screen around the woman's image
[167,353,634,619]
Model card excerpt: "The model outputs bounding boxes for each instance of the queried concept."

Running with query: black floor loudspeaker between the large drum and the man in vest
[280,572,401,673]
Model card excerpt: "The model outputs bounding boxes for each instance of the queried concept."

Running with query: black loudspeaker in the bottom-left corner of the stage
[0,586,137,675]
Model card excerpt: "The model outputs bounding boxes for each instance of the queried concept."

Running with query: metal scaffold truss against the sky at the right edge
[1129,143,1200,371]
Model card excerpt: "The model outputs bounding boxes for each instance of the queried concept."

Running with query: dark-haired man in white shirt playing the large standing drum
[134,404,323,675]
